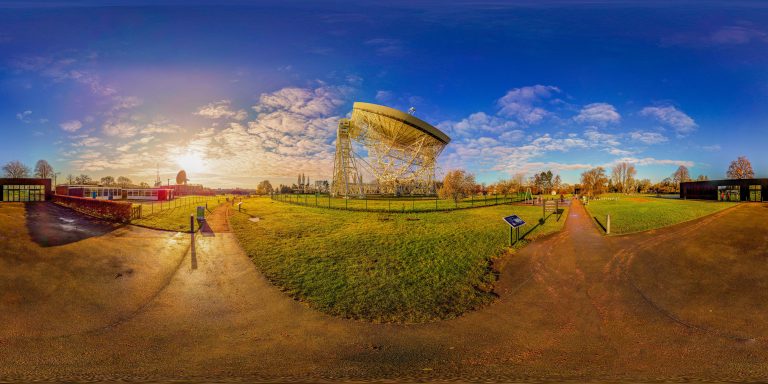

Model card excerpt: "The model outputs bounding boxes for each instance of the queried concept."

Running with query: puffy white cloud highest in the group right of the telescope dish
[497,85,560,124]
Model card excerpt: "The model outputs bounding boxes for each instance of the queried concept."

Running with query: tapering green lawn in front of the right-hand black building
[587,195,735,235]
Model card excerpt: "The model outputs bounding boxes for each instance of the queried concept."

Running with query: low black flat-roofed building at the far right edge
[680,179,768,201]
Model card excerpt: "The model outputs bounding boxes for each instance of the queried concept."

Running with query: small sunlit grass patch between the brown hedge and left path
[131,196,225,232]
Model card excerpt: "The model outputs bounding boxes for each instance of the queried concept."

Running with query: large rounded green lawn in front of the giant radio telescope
[230,197,567,322]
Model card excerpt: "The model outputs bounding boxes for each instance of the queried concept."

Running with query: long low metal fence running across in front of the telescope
[270,193,523,213]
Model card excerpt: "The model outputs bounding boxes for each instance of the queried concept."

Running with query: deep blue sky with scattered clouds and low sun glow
[0,0,768,188]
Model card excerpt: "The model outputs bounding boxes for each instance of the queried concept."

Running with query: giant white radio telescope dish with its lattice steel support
[331,103,451,197]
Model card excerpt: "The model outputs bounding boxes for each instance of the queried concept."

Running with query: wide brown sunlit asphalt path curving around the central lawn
[0,202,768,382]
